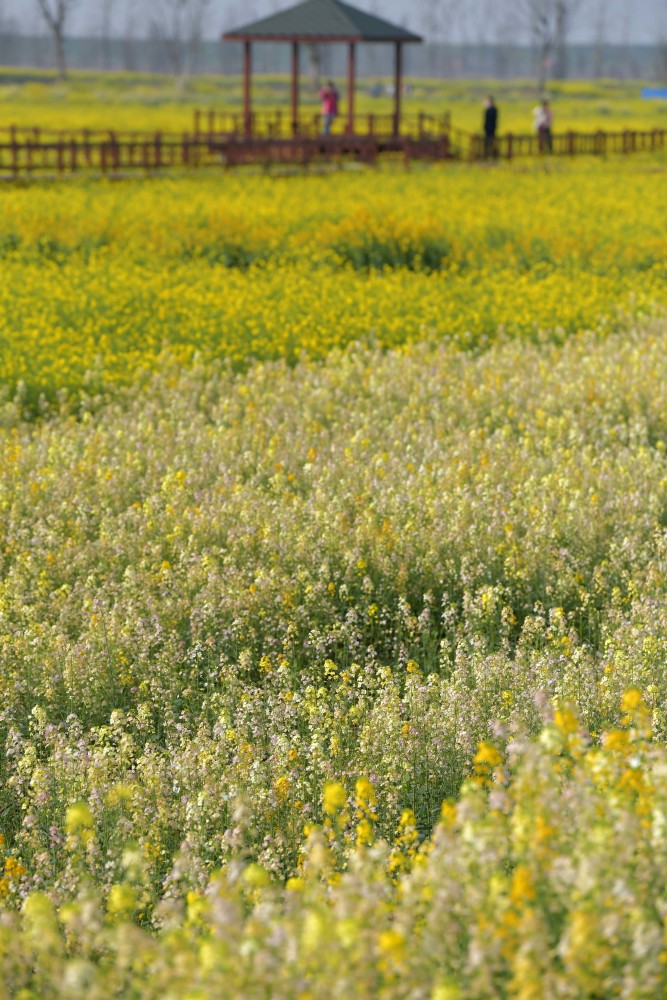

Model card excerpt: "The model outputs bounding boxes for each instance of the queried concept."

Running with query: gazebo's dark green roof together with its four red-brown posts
[222,0,421,136]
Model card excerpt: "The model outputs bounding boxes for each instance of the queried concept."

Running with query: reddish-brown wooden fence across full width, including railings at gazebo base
[0,122,667,179]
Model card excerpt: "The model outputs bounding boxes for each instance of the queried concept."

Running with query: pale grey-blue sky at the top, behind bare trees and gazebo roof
[6,0,667,44]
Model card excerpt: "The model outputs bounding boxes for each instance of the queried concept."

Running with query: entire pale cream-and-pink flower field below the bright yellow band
[0,328,667,998]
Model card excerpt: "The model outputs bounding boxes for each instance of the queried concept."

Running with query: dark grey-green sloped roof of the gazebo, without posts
[223,0,421,42]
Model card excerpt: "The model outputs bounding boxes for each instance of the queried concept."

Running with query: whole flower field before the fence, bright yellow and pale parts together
[0,82,667,1000]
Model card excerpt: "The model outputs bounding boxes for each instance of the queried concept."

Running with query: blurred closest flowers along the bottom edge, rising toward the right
[0,689,667,1000]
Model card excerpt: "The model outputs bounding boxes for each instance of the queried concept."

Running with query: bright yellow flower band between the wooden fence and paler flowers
[0,160,667,405]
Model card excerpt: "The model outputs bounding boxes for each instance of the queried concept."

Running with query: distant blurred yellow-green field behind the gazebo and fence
[0,69,667,132]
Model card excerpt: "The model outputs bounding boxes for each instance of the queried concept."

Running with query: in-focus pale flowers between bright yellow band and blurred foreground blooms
[0,322,667,898]
